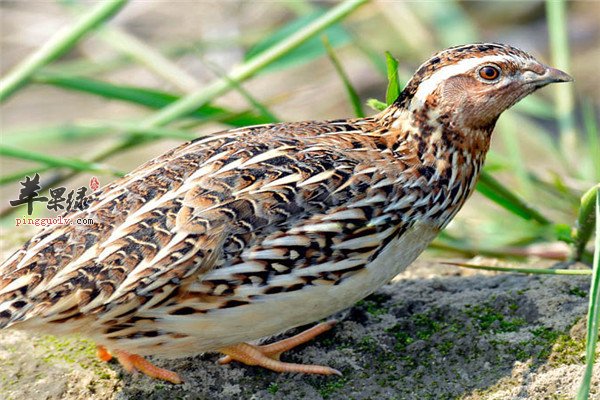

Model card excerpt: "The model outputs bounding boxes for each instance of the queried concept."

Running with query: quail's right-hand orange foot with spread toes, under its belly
[219,321,342,376]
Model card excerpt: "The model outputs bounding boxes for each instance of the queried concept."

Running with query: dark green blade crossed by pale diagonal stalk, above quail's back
[33,73,271,126]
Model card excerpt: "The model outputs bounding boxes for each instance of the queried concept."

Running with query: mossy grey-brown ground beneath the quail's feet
[0,256,600,400]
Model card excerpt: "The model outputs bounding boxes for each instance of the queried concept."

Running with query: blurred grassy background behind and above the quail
[0,0,600,259]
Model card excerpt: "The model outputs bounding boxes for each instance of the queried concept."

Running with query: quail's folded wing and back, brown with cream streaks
[0,123,408,327]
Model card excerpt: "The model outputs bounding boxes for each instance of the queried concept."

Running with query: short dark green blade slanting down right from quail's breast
[477,171,551,225]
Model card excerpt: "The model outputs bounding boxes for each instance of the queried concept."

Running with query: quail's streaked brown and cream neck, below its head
[378,101,493,228]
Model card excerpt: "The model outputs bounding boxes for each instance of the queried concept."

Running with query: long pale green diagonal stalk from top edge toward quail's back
[142,0,367,126]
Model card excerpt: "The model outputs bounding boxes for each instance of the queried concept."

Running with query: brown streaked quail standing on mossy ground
[0,43,572,383]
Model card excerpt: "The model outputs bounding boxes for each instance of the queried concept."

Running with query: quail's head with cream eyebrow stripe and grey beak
[397,43,573,129]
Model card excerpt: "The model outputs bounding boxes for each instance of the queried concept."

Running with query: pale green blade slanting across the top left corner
[0,0,127,102]
